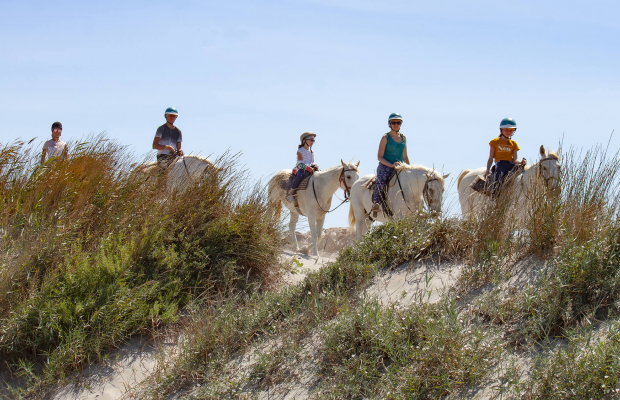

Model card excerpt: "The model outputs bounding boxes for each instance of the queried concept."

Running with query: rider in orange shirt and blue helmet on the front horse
[484,118,526,197]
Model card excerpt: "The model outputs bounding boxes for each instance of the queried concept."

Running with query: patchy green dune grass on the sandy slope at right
[128,145,620,399]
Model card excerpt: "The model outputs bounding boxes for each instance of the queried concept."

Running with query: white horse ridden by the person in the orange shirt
[457,146,560,217]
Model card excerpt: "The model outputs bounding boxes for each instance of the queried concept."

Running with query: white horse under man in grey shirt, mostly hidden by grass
[133,155,217,191]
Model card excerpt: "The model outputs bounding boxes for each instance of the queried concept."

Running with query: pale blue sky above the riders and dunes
[0,0,620,226]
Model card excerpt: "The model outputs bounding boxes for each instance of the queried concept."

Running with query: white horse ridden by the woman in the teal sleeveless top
[349,165,450,241]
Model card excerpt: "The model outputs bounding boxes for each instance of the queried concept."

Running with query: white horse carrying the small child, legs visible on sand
[269,160,360,256]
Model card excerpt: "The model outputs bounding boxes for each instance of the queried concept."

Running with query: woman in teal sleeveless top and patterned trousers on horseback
[371,113,409,212]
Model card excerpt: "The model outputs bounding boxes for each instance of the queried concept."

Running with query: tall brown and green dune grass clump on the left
[0,135,282,391]
